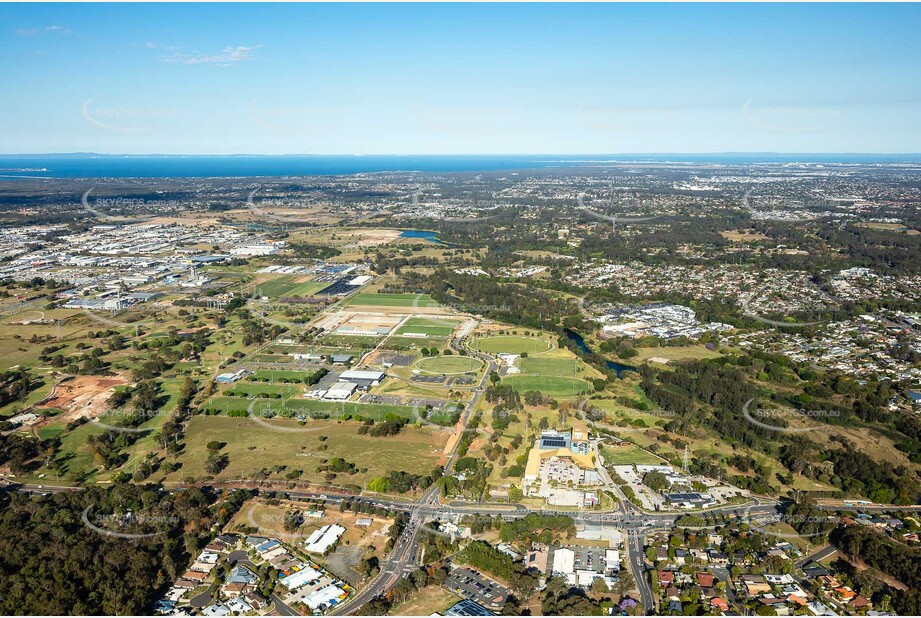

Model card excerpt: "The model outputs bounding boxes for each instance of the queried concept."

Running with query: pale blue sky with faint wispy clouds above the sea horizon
[0,4,921,154]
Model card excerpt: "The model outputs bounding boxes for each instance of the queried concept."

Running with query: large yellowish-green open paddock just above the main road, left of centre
[167,416,446,487]
